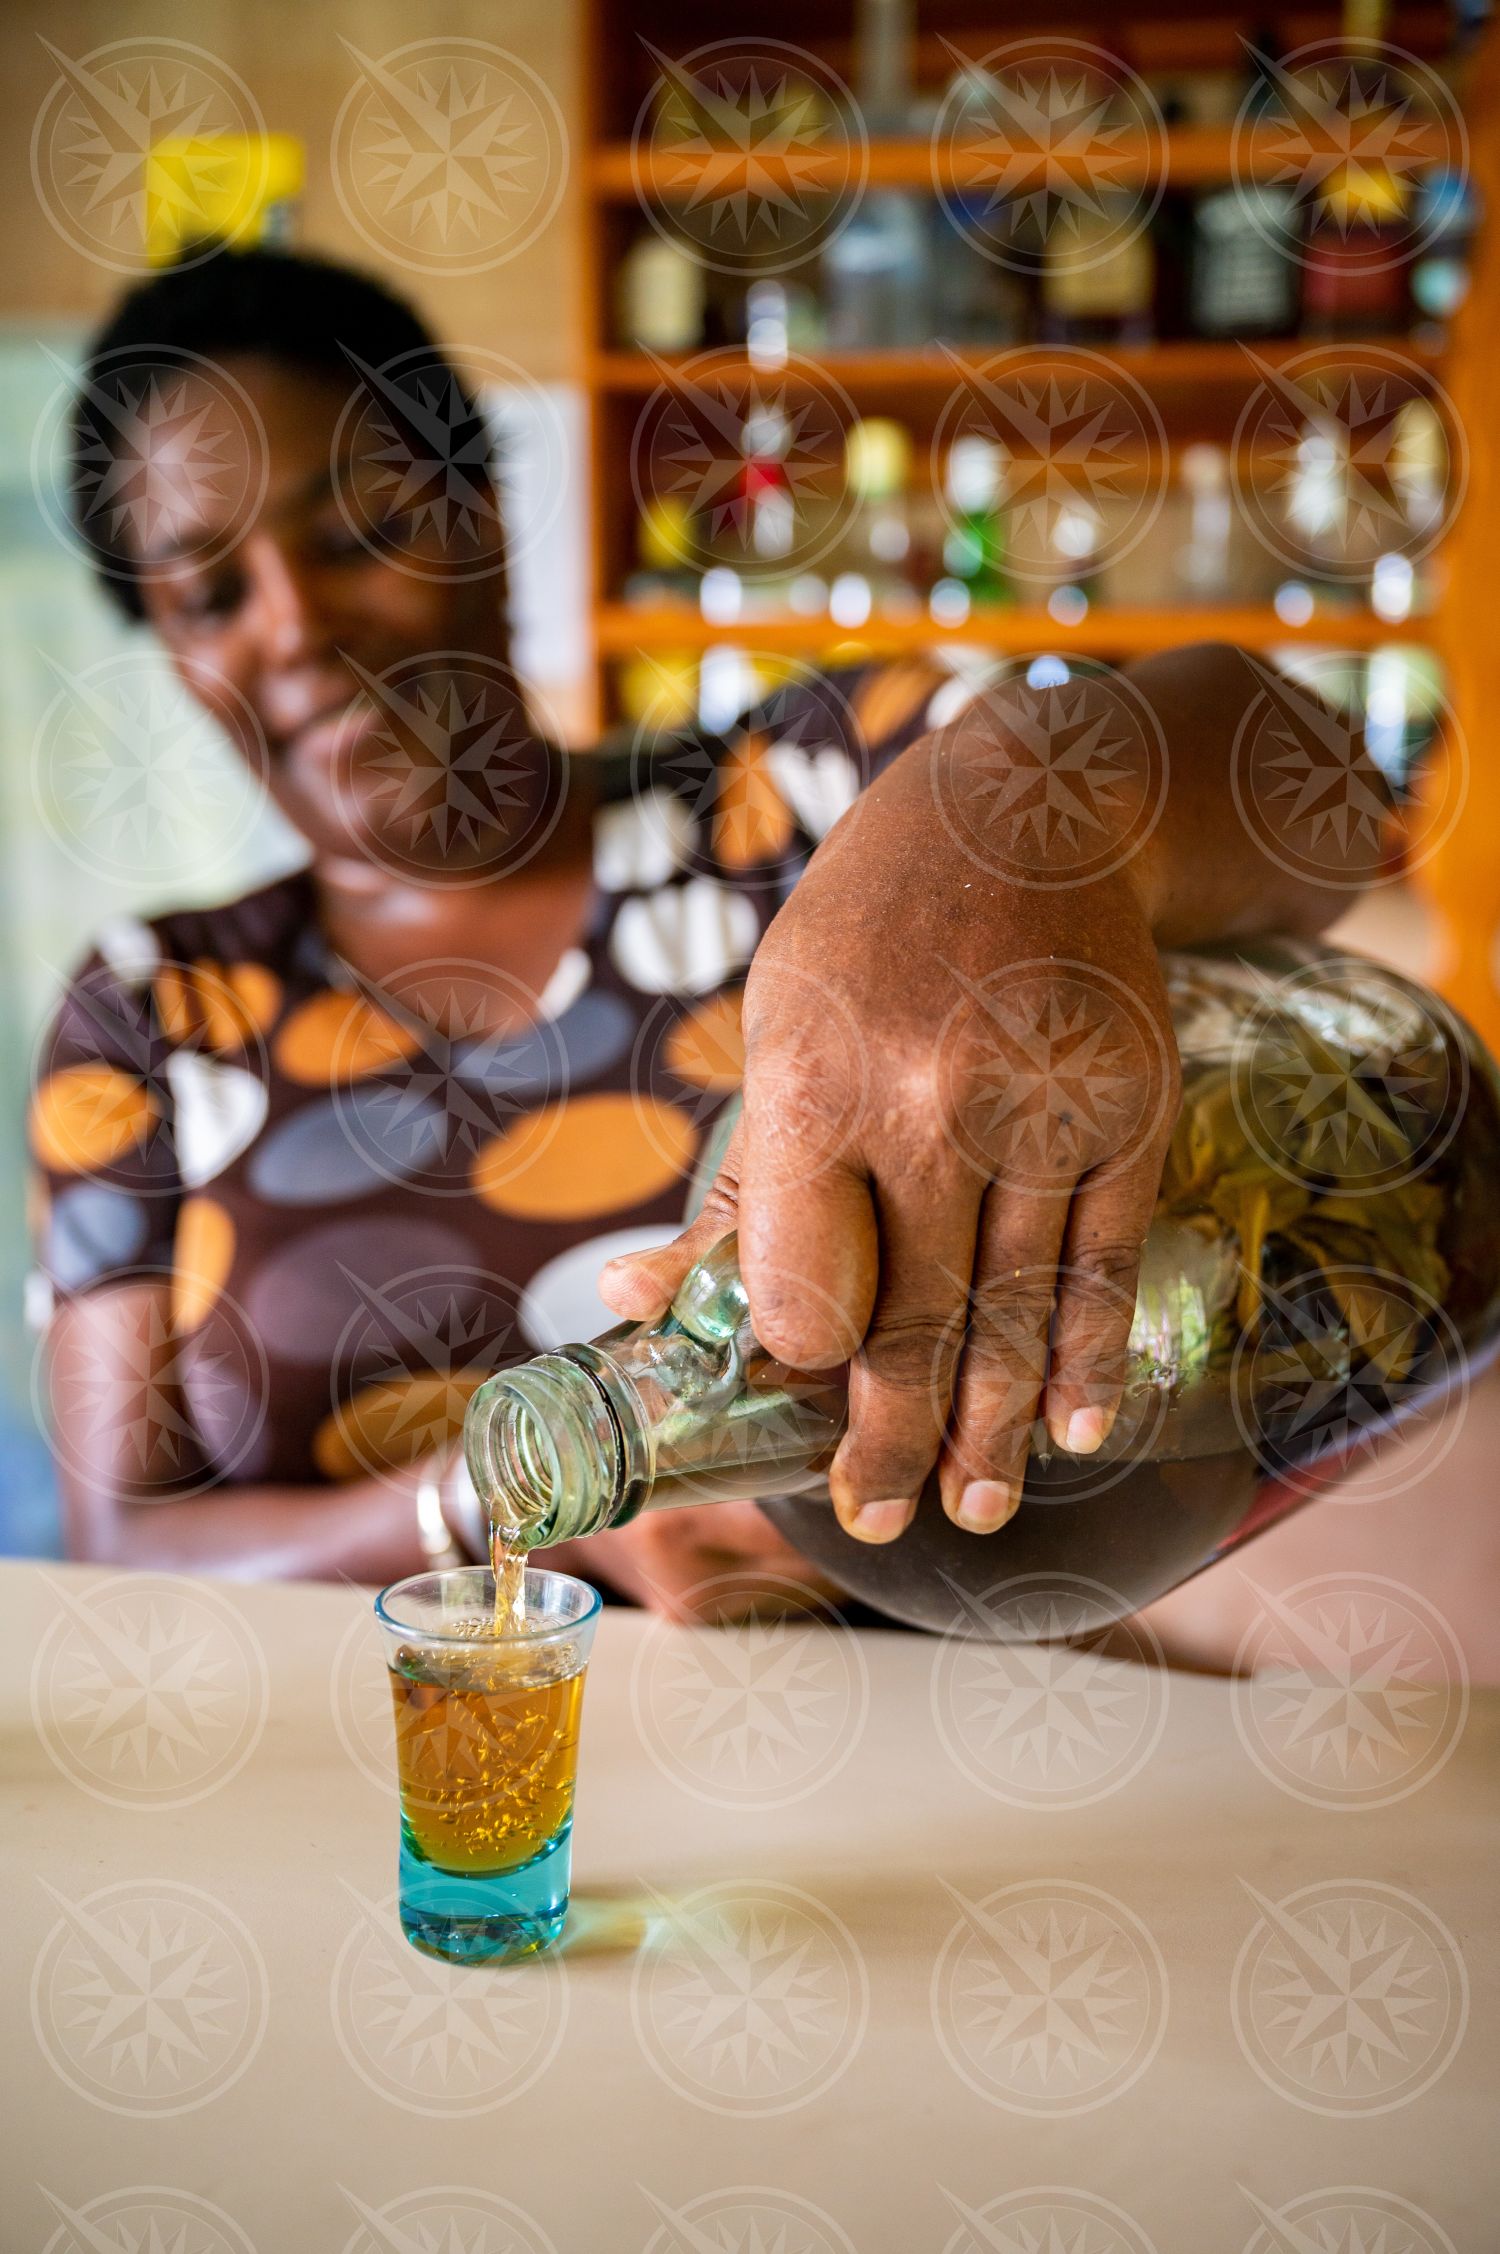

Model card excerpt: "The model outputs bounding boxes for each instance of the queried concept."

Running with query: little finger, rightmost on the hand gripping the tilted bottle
[1047,1154,1162,1456]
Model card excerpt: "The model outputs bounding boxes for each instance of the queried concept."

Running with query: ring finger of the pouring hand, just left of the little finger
[938,1183,1071,1535]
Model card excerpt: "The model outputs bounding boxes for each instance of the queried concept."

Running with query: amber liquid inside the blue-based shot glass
[390,1649,584,1873]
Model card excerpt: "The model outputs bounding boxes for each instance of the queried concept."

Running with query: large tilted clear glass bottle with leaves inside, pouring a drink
[465,944,1500,1634]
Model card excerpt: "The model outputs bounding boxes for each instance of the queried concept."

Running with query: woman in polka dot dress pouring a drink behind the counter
[32,252,1380,1609]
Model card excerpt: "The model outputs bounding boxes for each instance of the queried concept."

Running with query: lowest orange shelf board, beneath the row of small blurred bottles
[593,602,1432,658]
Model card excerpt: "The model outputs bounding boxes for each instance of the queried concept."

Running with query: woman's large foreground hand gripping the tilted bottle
[602,683,1177,1542]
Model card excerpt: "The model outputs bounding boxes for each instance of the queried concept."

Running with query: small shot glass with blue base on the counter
[374,1567,600,1963]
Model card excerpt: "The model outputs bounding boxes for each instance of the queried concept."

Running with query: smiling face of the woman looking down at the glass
[131,356,548,884]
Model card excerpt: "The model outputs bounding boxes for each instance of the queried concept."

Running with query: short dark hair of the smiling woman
[68,243,483,618]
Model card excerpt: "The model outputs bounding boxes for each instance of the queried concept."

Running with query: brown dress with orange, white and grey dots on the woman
[29,665,943,1481]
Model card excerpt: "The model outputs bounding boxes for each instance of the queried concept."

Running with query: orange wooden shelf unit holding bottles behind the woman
[580,0,1444,726]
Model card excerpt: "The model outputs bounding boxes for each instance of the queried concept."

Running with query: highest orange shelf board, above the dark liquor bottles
[589,126,1453,203]
